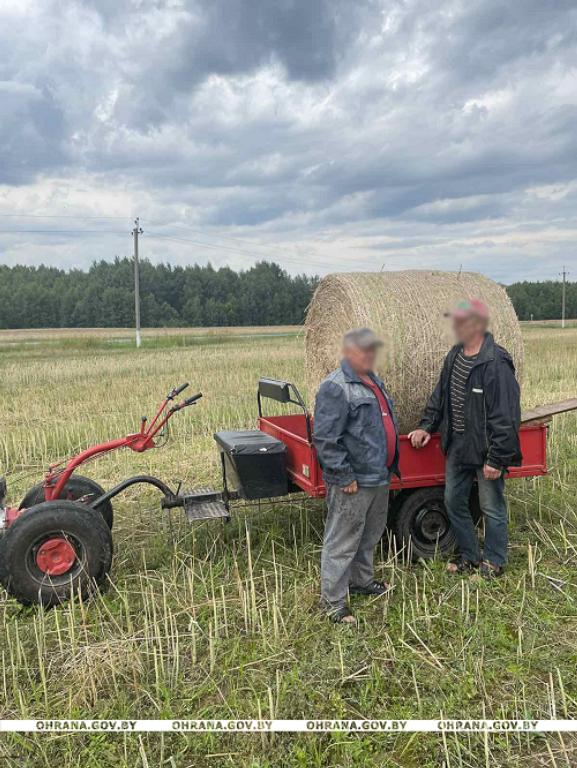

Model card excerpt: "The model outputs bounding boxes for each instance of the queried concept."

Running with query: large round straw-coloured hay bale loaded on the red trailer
[306,270,523,433]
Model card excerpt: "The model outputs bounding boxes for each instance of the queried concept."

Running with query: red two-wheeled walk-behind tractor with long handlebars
[0,383,202,606]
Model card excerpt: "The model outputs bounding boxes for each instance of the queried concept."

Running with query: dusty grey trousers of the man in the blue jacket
[321,483,389,609]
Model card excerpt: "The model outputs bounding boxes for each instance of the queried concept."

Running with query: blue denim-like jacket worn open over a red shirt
[314,360,400,487]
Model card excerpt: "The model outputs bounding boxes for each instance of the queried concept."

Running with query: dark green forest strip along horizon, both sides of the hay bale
[0,257,577,329]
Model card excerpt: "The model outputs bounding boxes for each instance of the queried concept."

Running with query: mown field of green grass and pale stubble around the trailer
[0,325,577,768]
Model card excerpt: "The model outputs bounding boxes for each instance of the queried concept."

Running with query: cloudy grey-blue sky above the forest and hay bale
[0,0,577,283]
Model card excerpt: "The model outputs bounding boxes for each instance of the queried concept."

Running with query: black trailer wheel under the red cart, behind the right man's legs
[392,484,482,560]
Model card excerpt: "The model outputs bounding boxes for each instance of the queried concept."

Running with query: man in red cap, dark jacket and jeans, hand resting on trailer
[409,301,522,579]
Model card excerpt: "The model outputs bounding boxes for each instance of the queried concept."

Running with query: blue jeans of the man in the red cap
[445,432,508,566]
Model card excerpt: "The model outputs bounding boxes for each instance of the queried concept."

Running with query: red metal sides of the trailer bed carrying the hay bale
[258,413,547,499]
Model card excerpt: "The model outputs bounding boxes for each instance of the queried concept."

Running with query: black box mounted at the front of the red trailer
[214,430,288,501]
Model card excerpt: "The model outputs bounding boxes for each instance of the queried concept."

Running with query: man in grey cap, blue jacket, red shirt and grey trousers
[314,328,399,623]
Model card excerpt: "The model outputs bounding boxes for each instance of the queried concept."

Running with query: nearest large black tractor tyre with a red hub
[0,500,112,607]
